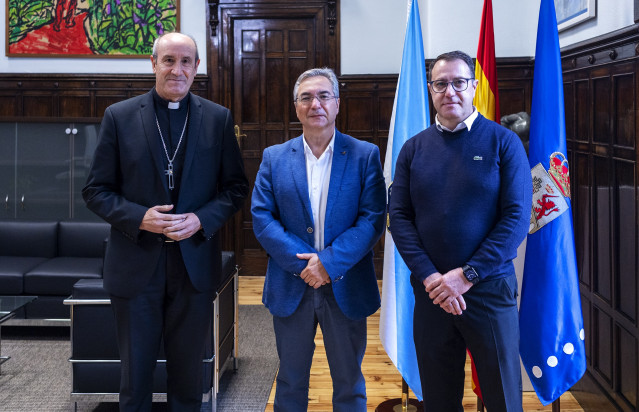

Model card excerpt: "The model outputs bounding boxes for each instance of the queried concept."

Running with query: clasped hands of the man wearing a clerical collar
[140,205,202,241]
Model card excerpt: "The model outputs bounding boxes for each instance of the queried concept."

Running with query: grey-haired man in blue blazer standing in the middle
[251,68,386,412]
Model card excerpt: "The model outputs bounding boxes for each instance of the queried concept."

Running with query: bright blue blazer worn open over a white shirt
[251,131,386,319]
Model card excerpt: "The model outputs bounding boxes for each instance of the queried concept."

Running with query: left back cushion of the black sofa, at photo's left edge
[0,220,58,258]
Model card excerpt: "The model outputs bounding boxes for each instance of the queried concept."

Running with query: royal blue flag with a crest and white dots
[519,0,586,405]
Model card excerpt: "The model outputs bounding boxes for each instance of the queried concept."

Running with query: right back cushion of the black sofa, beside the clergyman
[58,220,111,257]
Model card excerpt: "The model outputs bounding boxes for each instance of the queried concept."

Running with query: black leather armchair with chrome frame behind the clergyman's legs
[65,252,239,411]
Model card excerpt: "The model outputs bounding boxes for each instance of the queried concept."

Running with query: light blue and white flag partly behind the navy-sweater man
[379,0,430,400]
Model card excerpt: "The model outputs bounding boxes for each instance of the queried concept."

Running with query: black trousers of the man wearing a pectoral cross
[111,243,213,412]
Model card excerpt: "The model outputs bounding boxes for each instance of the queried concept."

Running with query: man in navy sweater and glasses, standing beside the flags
[390,51,532,412]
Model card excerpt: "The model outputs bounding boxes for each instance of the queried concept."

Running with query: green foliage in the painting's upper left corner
[9,0,55,44]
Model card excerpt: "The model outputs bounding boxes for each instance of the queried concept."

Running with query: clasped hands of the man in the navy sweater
[424,268,473,315]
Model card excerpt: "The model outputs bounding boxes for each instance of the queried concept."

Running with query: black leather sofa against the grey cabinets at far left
[0,220,109,325]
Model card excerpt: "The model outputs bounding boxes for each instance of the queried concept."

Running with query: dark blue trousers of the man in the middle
[273,284,366,412]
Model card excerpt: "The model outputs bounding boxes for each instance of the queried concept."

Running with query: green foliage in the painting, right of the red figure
[85,0,177,55]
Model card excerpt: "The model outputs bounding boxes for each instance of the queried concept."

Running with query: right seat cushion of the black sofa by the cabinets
[24,257,102,297]
